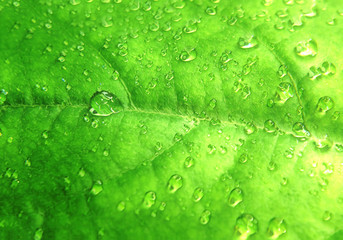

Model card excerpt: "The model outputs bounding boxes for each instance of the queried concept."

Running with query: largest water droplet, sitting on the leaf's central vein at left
[89,91,123,116]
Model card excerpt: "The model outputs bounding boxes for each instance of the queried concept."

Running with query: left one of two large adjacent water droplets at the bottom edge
[235,213,258,240]
